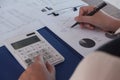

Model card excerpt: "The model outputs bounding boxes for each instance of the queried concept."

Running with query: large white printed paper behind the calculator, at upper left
[0,0,86,45]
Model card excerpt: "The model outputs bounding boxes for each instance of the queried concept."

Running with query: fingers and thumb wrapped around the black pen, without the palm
[75,6,95,29]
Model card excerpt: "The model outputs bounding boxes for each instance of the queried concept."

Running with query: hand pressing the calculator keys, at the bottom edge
[19,56,55,80]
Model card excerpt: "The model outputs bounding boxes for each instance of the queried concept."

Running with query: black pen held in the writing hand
[71,2,107,28]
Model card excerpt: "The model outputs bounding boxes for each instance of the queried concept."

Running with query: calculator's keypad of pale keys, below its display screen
[17,42,64,66]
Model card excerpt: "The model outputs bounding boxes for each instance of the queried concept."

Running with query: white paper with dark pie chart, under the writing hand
[41,2,111,56]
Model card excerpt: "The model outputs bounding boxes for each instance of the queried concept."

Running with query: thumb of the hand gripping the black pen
[75,16,94,24]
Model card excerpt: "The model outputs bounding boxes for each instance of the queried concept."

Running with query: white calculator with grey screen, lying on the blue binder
[5,31,64,69]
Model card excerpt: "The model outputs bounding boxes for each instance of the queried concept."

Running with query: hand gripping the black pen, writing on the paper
[75,6,120,31]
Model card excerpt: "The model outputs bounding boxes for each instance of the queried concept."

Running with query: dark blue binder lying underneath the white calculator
[0,27,83,80]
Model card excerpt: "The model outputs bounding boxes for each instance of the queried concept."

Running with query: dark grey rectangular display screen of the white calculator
[11,36,40,49]
